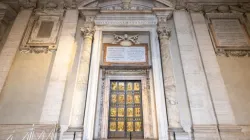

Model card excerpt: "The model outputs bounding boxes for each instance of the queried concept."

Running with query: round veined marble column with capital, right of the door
[158,27,181,129]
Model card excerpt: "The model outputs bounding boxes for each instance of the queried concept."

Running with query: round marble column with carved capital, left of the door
[70,27,94,128]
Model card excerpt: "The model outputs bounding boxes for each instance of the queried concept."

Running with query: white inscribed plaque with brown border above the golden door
[103,44,147,65]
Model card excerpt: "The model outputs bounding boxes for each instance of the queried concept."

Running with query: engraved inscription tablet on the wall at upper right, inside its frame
[212,19,249,48]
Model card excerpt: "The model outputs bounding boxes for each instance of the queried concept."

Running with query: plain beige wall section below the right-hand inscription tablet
[217,56,250,125]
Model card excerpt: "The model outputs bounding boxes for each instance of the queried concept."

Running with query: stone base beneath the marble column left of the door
[62,128,83,140]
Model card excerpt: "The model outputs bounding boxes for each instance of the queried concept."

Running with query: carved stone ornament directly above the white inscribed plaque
[112,34,140,46]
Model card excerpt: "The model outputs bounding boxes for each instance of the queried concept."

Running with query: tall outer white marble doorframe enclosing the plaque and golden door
[83,24,169,140]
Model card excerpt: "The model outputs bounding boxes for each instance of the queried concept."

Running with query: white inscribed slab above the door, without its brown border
[106,46,146,63]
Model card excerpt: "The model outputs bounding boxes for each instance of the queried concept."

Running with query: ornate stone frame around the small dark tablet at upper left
[19,9,64,53]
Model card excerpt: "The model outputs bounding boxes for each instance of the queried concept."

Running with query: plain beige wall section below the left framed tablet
[0,52,53,124]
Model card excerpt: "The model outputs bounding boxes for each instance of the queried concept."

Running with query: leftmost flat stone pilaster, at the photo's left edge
[0,10,32,92]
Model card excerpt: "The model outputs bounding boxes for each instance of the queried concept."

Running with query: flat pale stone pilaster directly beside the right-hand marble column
[174,10,217,125]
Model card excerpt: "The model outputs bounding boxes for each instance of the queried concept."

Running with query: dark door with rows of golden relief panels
[108,81,143,138]
